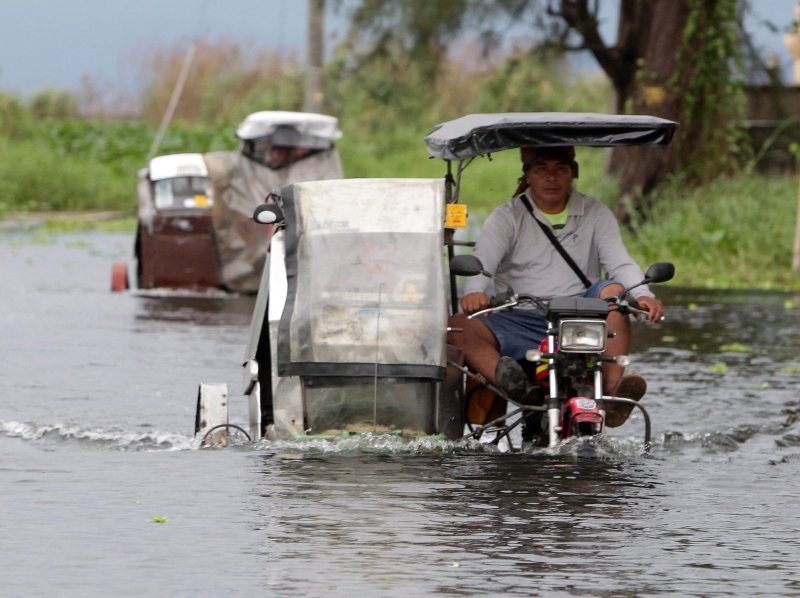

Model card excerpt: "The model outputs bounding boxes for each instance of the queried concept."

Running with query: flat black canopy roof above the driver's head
[425,112,678,160]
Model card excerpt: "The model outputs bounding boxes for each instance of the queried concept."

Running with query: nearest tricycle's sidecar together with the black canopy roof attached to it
[195,113,677,444]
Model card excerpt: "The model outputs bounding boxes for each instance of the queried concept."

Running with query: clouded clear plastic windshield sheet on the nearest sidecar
[278,179,447,380]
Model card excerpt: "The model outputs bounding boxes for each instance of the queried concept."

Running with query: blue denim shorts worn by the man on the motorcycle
[481,280,614,360]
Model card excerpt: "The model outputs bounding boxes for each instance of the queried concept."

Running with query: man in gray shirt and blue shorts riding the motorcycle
[448,146,663,427]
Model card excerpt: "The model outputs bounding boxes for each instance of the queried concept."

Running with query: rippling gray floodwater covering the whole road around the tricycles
[0,232,800,597]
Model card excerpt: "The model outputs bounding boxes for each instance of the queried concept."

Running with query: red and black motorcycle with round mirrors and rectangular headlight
[450,255,675,448]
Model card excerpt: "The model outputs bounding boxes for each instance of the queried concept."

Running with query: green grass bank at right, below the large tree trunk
[626,175,800,289]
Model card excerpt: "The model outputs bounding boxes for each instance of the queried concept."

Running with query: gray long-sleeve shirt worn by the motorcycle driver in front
[464,189,654,298]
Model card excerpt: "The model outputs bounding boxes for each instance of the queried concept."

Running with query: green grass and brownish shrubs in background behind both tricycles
[0,36,800,290]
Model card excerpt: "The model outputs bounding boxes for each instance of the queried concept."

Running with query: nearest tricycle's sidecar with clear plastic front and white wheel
[196,179,463,440]
